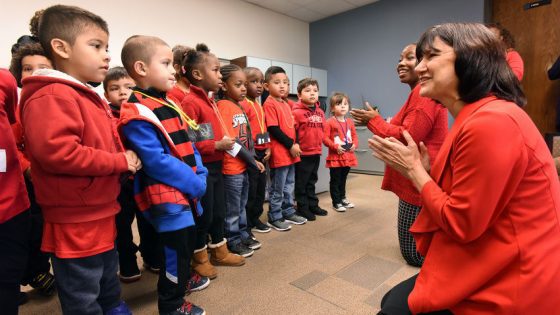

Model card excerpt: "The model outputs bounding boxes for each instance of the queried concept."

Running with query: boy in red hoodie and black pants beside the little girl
[292,78,328,221]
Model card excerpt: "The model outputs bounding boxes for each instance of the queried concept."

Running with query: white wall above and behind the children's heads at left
[0,0,309,67]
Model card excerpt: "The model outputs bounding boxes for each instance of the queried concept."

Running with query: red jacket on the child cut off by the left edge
[0,69,29,224]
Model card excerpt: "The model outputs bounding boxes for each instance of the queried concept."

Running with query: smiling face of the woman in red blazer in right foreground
[416,37,459,105]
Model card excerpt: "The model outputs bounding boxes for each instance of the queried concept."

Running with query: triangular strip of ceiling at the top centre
[243,0,379,23]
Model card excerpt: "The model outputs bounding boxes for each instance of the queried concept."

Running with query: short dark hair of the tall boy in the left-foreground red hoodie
[37,5,109,59]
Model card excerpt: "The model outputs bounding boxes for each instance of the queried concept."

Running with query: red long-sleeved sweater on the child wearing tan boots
[181,85,225,163]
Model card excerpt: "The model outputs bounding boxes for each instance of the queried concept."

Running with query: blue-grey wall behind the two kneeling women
[310,0,484,116]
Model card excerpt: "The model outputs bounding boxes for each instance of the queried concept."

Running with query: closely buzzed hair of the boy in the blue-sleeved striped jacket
[121,35,169,78]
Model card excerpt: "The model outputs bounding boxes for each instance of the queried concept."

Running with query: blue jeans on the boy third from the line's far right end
[268,164,296,222]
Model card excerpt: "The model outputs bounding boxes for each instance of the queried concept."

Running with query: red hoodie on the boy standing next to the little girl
[292,101,325,155]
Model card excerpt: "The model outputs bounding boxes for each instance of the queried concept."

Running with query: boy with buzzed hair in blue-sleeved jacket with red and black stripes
[119,35,210,315]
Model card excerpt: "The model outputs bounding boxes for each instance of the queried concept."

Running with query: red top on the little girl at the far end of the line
[323,117,358,168]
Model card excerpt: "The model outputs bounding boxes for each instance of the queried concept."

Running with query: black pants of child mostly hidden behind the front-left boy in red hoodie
[22,178,51,285]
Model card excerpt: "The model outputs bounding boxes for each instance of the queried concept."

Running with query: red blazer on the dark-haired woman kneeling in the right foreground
[408,97,560,315]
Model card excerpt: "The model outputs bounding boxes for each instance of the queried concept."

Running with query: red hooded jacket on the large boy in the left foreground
[20,70,128,223]
